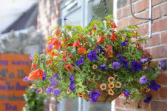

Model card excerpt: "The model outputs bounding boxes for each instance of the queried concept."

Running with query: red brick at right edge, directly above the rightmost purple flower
[152,45,167,58]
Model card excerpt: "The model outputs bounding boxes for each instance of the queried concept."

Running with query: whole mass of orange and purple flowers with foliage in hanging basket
[23,16,165,103]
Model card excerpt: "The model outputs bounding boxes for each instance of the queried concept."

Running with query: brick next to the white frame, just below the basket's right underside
[115,98,135,109]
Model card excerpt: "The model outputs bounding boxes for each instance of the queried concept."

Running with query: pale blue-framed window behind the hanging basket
[58,0,113,111]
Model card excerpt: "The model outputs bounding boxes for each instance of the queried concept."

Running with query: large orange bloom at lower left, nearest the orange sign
[28,69,43,81]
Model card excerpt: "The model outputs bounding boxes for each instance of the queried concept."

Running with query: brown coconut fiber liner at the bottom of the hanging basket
[83,81,121,103]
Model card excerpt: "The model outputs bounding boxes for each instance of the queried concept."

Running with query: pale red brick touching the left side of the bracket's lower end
[137,24,148,36]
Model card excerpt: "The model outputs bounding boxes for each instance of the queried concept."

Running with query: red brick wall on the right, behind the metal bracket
[115,0,167,111]
